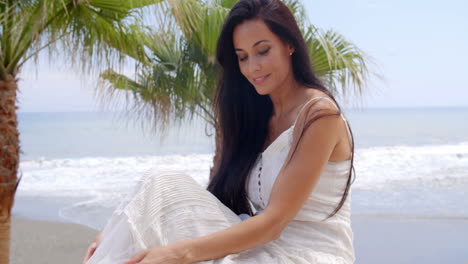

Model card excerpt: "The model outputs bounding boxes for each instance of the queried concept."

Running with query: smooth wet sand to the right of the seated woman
[352,216,468,264]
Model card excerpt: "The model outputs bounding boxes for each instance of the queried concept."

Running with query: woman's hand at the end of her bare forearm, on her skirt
[125,246,190,264]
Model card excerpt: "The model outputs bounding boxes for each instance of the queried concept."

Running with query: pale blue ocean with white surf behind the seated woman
[13,108,468,228]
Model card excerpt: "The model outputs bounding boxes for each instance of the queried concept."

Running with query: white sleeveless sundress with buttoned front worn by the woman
[87,97,355,264]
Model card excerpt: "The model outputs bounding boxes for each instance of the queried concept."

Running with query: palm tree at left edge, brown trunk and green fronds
[0,0,158,263]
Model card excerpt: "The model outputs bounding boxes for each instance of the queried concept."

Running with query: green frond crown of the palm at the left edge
[0,0,161,79]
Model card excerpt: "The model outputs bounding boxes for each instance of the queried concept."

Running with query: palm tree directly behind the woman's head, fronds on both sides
[100,0,370,177]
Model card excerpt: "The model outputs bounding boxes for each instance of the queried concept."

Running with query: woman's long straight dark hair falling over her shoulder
[207,0,354,217]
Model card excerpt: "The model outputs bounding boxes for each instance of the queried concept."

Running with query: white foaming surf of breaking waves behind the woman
[17,142,468,228]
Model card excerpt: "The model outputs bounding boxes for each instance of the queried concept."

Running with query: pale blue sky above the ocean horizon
[18,0,468,112]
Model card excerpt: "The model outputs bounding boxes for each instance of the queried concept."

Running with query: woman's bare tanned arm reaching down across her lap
[129,116,343,263]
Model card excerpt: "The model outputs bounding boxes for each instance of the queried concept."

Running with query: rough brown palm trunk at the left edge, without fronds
[0,76,19,264]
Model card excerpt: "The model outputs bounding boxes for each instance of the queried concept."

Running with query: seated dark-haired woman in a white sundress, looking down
[84,0,354,264]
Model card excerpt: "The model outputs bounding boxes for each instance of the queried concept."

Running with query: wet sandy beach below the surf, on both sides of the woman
[11,216,468,264]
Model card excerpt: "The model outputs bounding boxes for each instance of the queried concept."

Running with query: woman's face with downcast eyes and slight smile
[233,19,294,95]
